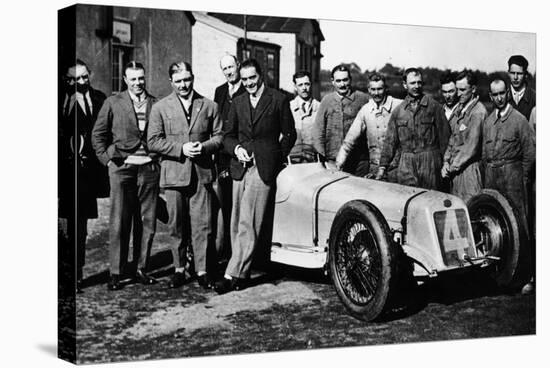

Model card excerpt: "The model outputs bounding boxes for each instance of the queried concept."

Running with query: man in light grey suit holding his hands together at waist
[148,62,222,289]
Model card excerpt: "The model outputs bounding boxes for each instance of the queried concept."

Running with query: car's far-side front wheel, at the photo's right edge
[468,189,529,288]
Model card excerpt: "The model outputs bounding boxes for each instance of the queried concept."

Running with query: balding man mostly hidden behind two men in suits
[213,54,246,258]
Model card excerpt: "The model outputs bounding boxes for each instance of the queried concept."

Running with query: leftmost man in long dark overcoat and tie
[58,59,109,292]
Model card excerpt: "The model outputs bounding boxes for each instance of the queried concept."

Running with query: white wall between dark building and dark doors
[192,20,238,99]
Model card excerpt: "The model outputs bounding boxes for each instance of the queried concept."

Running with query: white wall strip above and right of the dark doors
[249,32,296,93]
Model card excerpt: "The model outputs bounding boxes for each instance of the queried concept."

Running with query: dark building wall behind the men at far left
[72,4,192,97]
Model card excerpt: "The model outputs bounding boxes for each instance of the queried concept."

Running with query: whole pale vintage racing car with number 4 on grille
[271,145,528,321]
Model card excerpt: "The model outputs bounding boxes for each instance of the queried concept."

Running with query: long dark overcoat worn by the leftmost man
[58,88,109,218]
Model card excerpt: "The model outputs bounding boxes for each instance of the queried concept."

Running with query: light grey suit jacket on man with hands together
[147,91,222,188]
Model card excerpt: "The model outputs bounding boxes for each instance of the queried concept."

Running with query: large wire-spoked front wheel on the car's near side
[329,200,398,321]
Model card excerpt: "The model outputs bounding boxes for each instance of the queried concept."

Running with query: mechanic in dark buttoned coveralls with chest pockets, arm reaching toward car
[376,68,450,189]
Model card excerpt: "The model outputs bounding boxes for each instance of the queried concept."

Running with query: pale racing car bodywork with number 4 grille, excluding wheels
[271,162,488,277]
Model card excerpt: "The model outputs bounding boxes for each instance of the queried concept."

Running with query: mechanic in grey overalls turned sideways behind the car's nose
[441,70,487,202]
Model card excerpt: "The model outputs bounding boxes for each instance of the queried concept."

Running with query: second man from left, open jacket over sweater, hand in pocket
[92,61,160,290]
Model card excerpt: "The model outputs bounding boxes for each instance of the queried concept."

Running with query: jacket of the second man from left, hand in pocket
[92,91,157,165]
